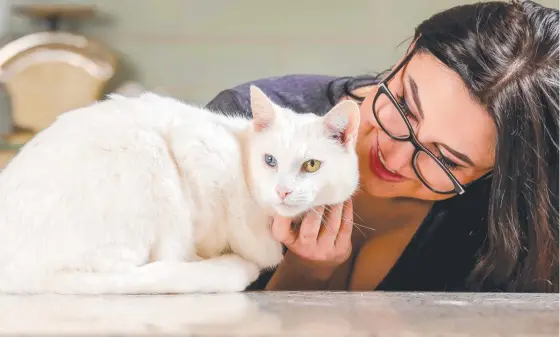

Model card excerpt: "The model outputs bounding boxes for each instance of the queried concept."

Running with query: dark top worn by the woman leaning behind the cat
[207,75,494,291]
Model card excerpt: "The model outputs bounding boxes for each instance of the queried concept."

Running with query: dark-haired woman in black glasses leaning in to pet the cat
[208,1,559,292]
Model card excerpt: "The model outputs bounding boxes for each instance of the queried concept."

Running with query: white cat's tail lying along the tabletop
[0,254,259,295]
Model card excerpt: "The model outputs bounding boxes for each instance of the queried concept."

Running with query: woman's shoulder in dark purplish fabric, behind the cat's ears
[206,74,352,115]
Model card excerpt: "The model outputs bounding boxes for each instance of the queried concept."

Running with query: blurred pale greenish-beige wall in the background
[0,0,558,104]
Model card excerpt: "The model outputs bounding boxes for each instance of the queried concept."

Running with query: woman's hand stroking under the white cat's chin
[272,200,353,278]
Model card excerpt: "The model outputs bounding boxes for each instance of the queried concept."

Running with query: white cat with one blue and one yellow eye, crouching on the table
[0,87,359,294]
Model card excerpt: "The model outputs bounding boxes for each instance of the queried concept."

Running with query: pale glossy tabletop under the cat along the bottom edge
[0,292,559,337]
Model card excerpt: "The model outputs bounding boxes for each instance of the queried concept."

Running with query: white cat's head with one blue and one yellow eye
[247,86,360,217]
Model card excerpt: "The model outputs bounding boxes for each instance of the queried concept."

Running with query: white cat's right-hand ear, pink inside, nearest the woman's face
[323,100,360,148]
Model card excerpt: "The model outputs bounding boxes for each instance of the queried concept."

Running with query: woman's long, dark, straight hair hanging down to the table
[332,1,560,292]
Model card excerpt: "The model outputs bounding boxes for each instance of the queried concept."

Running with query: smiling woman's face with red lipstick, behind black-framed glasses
[357,53,496,200]
